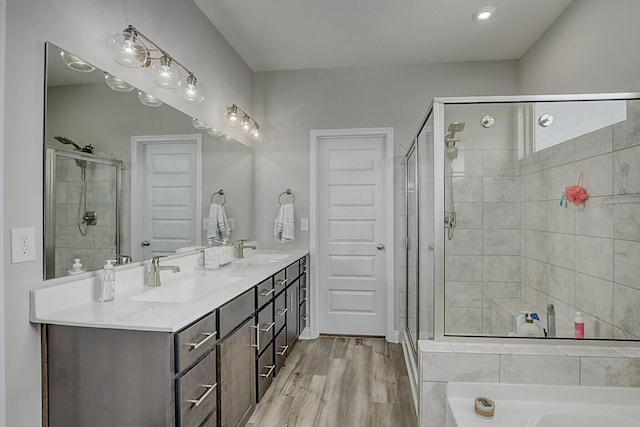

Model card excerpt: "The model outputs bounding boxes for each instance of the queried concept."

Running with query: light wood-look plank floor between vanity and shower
[247,336,417,427]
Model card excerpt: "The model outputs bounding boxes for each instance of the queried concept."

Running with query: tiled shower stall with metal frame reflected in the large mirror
[44,147,122,279]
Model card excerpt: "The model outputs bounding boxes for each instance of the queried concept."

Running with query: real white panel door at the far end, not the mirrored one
[317,135,392,336]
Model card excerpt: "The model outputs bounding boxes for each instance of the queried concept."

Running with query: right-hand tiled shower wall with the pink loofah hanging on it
[521,101,640,339]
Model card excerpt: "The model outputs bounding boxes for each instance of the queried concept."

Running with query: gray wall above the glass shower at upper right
[519,0,640,94]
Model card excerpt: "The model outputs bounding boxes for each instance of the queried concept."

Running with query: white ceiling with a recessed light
[194,0,571,71]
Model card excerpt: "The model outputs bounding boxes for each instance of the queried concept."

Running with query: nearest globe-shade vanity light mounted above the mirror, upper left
[111,25,204,105]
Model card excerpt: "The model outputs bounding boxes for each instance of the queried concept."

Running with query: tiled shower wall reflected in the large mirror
[55,158,116,277]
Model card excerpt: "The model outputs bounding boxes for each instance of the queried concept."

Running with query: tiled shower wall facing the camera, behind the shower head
[445,105,521,334]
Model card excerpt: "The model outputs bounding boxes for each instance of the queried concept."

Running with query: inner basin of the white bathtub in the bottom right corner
[528,412,640,427]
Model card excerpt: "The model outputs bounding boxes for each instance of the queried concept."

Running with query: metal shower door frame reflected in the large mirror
[43,147,122,280]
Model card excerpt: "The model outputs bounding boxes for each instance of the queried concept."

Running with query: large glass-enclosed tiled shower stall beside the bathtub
[406,93,640,354]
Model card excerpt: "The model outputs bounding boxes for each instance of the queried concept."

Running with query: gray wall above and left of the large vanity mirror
[1,0,254,426]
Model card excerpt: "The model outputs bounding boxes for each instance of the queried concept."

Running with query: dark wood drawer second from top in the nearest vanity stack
[176,350,218,426]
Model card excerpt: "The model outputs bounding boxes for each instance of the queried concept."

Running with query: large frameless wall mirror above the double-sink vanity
[44,43,253,279]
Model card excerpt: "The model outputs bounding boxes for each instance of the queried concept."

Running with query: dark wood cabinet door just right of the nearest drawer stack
[217,315,256,427]
